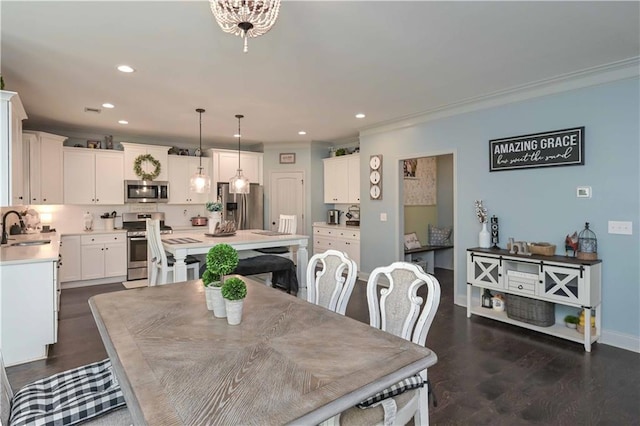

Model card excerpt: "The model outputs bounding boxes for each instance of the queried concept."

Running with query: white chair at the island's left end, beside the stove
[147,219,200,286]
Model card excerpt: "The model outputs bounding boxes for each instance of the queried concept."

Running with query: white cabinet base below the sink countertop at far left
[0,261,57,366]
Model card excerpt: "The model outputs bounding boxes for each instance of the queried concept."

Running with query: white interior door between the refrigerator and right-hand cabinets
[268,171,306,234]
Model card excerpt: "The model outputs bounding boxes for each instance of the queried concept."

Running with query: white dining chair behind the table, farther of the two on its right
[307,250,358,315]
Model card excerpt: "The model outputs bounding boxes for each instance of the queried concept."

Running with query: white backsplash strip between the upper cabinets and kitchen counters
[1,203,207,233]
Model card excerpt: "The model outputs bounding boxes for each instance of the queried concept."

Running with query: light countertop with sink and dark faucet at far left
[0,232,60,266]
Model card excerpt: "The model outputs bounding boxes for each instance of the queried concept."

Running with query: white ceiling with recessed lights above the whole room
[0,0,640,150]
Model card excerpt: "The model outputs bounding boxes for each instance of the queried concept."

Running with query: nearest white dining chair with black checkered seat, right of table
[336,262,440,425]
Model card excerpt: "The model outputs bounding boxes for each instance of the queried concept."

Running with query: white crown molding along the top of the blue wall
[360,57,640,136]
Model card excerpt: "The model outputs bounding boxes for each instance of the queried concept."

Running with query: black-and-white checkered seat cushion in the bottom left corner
[9,359,125,426]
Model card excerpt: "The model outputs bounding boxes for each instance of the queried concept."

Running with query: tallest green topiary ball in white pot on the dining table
[202,244,238,318]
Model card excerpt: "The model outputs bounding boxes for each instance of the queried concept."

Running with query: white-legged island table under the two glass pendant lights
[162,229,309,288]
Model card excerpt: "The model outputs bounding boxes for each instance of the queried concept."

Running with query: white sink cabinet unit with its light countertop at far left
[0,233,60,366]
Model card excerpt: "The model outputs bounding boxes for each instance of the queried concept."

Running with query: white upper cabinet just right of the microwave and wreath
[168,155,215,205]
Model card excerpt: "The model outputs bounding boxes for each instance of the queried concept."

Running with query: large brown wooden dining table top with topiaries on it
[89,277,437,426]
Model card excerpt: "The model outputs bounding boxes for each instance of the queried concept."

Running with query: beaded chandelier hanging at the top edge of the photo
[209,0,280,53]
